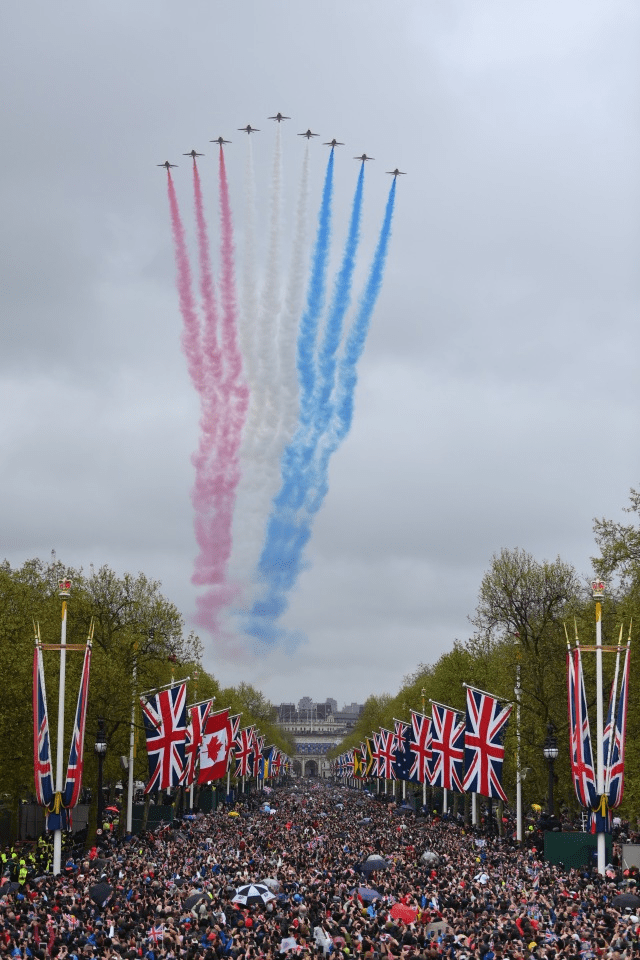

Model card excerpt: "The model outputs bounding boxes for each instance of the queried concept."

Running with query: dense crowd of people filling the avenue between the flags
[0,781,640,960]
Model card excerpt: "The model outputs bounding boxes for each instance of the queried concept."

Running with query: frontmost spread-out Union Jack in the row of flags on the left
[140,683,187,793]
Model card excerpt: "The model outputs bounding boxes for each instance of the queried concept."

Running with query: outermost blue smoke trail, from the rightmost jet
[247,180,396,644]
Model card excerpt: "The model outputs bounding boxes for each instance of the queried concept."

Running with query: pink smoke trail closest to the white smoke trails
[193,149,249,630]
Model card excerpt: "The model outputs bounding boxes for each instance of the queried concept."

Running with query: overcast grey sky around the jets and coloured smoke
[0,0,640,703]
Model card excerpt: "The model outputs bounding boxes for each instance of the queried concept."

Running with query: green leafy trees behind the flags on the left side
[0,557,293,801]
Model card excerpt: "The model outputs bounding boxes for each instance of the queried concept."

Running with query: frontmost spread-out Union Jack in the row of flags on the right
[462,687,511,800]
